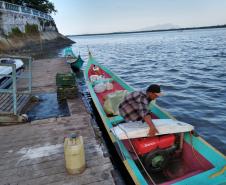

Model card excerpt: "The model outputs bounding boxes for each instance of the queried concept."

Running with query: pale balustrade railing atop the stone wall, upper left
[0,1,53,21]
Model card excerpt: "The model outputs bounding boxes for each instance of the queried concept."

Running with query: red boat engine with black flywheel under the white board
[131,134,176,172]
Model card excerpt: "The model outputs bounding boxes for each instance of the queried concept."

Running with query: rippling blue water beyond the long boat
[67,29,226,154]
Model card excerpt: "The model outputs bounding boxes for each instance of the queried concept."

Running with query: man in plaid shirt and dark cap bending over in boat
[119,84,162,136]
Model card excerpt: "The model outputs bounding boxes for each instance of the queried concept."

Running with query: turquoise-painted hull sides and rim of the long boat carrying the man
[84,54,226,185]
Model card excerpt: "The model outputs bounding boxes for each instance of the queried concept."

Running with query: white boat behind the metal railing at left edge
[0,58,24,88]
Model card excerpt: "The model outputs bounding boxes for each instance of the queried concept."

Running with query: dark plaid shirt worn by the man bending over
[119,91,151,121]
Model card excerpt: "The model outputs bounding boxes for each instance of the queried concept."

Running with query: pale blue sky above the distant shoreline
[50,0,226,35]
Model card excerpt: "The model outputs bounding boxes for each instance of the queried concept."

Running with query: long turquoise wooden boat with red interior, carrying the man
[84,54,226,185]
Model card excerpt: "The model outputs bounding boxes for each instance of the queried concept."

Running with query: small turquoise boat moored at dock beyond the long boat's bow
[64,47,84,72]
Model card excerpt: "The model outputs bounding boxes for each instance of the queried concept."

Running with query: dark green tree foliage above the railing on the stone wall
[4,0,57,13]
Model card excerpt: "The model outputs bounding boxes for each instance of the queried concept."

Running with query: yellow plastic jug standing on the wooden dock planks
[64,135,85,174]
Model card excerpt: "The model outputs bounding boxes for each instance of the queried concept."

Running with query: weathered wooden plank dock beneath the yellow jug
[0,58,115,185]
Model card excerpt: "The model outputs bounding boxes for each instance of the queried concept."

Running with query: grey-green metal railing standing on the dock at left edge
[0,55,32,115]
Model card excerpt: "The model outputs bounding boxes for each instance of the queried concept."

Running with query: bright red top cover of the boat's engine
[132,134,175,155]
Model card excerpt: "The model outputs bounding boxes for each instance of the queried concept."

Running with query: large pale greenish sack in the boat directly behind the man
[104,90,128,115]
